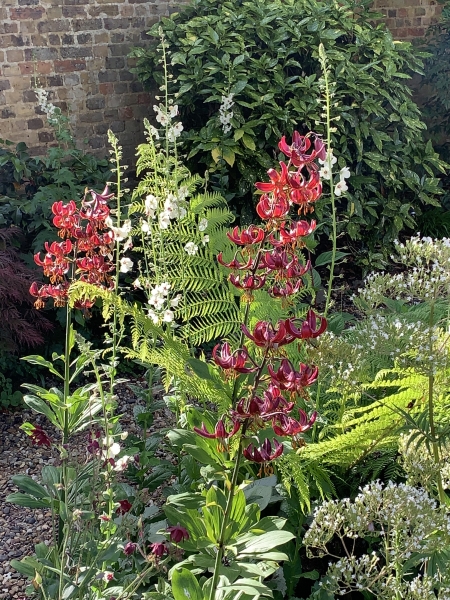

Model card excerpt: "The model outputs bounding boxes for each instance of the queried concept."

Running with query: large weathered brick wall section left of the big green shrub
[0,0,187,162]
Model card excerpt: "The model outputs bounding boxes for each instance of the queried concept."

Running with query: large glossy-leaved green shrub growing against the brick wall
[133,0,446,253]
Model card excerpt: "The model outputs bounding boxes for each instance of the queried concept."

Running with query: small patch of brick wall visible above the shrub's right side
[373,0,442,40]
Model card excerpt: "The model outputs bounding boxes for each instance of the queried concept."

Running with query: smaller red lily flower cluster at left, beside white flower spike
[30,186,116,311]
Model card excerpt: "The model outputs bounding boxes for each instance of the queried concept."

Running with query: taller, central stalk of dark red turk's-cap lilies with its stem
[194,132,327,600]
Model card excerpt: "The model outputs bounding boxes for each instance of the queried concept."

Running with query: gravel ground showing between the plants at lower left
[0,385,172,600]
